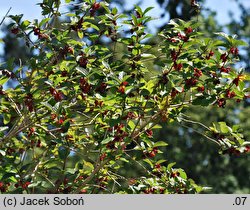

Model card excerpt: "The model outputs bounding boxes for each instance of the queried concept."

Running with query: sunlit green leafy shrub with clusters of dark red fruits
[0,0,249,193]
